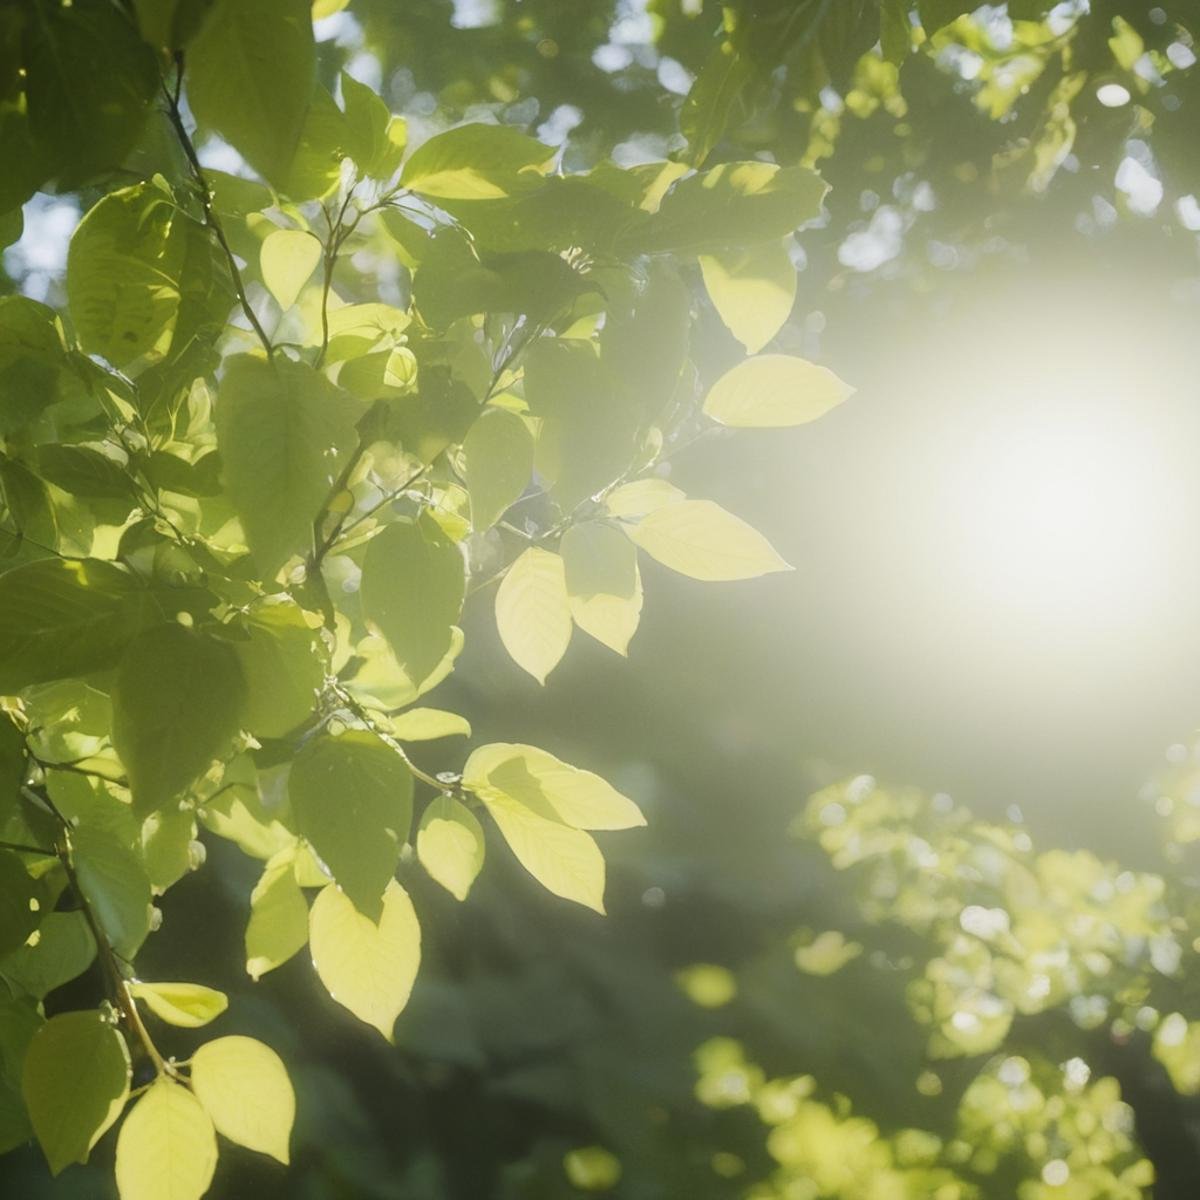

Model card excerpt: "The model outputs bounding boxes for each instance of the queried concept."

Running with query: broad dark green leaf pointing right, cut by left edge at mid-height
[0,558,152,695]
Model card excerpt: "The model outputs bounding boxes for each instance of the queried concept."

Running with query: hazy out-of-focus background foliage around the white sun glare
[0,0,1200,1200]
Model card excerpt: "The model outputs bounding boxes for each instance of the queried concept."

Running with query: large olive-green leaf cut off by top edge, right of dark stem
[187,0,317,187]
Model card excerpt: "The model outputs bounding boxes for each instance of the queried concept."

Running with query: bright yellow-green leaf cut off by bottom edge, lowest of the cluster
[116,1075,217,1200]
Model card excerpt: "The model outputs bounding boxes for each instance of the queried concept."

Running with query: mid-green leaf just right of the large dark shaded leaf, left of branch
[233,604,328,738]
